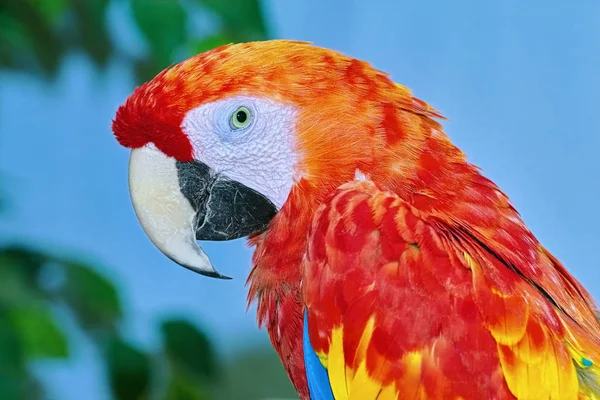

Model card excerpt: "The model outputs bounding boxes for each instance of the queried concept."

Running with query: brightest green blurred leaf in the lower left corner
[10,305,69,359]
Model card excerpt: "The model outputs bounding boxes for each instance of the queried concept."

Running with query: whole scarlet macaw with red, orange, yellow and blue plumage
[113,40,600,400]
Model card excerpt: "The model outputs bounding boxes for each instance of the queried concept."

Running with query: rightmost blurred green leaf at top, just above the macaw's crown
[196,0,267,42]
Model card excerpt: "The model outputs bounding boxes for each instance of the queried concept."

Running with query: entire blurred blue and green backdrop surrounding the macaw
[0,0,600,400]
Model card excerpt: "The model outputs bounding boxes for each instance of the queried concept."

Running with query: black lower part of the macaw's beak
[176,161,277,240]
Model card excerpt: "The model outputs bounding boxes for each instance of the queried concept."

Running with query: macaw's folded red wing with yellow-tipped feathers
[303,181,600,400]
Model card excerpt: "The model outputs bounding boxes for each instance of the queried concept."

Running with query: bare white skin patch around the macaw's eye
[182,96,297,210]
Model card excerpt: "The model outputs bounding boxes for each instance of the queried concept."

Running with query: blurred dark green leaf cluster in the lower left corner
[0,246,220,400]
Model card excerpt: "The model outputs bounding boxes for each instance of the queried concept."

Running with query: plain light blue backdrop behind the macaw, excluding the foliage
[0,0,600,400]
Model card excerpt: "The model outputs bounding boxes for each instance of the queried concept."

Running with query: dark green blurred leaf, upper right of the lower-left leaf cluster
[61,262,122,331]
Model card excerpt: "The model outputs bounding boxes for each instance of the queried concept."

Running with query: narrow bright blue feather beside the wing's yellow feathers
[302,311,335,400]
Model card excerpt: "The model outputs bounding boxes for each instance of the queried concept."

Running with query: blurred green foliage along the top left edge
[0,0,267,82]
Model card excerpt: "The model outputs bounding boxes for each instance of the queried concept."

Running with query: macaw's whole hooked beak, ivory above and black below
[129,144,276,279]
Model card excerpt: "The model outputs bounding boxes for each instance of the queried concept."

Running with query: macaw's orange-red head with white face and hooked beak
[113,40,442,278]
